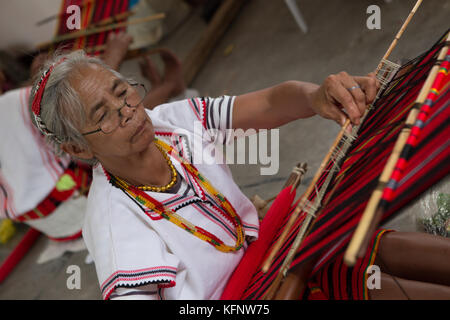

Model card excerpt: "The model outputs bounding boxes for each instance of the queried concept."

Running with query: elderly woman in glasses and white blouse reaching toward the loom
[30,51,377,299]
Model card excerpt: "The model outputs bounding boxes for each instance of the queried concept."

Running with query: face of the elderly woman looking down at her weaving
[70,64,154,162]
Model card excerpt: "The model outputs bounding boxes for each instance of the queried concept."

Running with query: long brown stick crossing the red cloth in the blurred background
[37,13,166,49]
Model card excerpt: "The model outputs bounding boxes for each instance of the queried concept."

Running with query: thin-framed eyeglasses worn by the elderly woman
[82,83,147,136]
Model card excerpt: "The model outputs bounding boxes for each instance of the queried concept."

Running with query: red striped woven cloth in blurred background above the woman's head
[56,0,129,55]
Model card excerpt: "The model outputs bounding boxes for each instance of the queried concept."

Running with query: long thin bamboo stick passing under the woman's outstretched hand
[262,0,423,273]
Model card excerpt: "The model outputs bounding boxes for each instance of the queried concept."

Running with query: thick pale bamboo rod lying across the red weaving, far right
[344,33,450,266]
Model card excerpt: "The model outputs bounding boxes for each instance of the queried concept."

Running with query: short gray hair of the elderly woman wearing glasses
[29,50,127,161]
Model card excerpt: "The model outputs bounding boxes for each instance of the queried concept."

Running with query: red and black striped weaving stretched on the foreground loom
[293,31,450,276]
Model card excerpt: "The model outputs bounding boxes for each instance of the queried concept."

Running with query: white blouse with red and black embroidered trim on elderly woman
[83,96,259,299]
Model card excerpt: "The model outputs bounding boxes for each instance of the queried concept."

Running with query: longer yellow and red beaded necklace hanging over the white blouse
[107,139,245,252]
